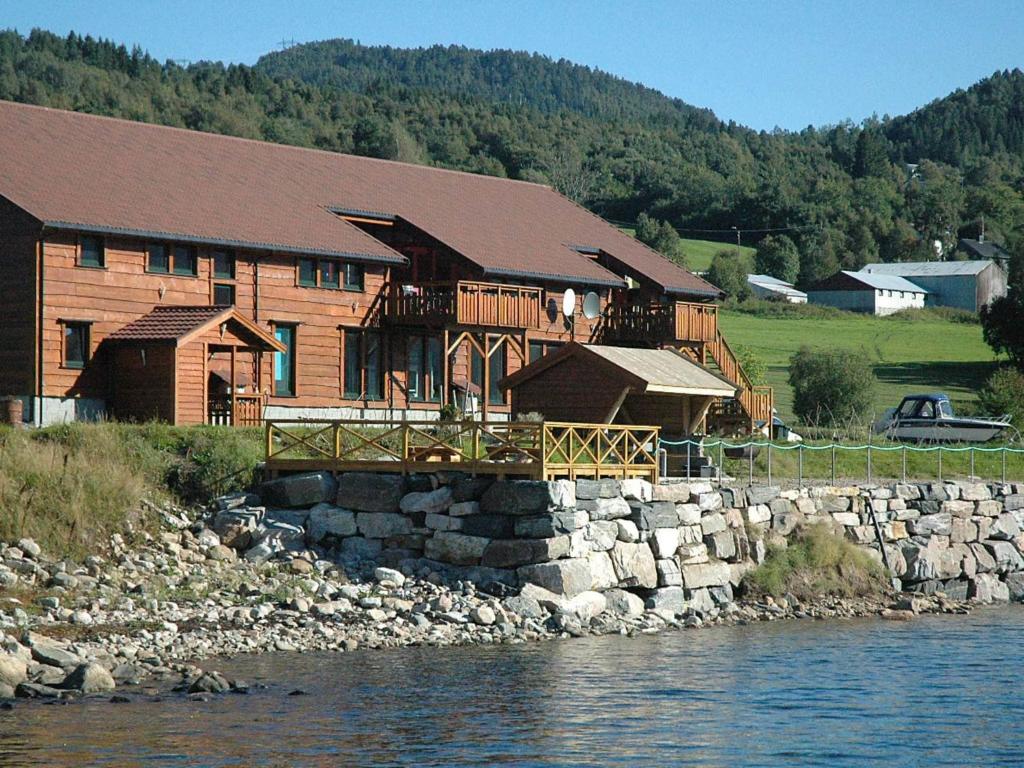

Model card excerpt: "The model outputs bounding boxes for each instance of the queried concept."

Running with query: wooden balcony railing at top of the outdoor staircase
[603,301,718,344]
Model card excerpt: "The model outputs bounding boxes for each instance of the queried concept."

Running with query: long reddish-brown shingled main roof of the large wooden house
[0,101,719,297]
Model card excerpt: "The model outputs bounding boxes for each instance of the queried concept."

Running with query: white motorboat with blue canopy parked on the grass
[874,392,1010,442]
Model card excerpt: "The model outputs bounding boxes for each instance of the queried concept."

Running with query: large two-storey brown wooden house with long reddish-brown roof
[0,101,771,429]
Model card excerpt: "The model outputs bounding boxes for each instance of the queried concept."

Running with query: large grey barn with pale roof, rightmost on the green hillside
[861,260,1007,312]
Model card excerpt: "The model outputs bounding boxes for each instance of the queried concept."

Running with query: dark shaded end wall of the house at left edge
[0,198,41,395]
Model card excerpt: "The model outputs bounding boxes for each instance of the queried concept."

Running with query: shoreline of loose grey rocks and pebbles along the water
[0,499,991,708]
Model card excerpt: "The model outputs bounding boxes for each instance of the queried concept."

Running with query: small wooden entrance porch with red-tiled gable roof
[104,306,286,426]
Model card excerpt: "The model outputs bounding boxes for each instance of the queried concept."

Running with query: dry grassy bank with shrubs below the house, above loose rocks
[0,423,263,558]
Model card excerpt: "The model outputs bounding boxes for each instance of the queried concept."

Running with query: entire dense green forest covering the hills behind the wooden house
[0,31,1024,284]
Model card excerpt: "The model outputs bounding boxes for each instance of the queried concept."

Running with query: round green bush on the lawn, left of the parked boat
[790,346,874,426]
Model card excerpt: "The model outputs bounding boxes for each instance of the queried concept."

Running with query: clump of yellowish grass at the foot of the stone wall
[743,524,889,602]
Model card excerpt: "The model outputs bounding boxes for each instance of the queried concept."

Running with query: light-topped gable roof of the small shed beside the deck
[500,342,736,397]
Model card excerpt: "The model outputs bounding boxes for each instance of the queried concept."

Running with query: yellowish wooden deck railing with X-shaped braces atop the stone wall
[265,420,658,481]
